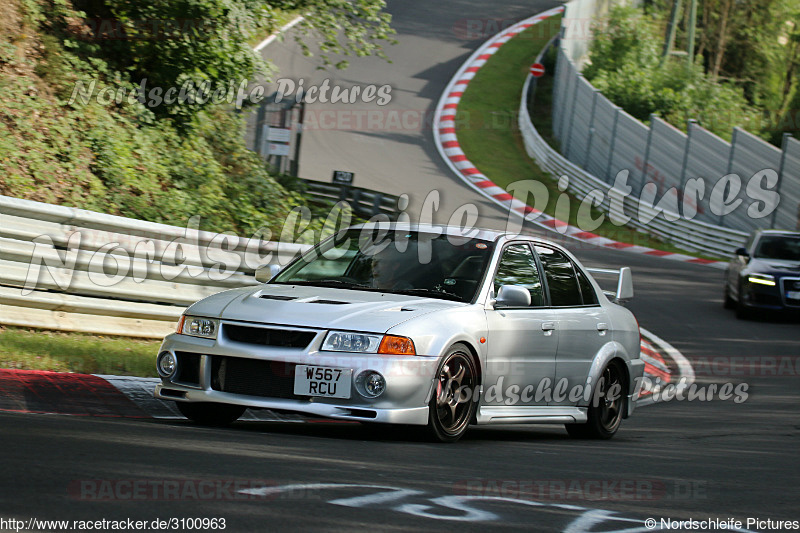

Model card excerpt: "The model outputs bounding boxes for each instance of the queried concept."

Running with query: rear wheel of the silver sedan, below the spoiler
[565,361,628,439]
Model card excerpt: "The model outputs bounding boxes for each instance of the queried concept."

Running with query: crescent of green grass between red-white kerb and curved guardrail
[456,16,717,259]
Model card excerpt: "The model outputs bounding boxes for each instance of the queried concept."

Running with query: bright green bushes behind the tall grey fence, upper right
[583,7,760,139]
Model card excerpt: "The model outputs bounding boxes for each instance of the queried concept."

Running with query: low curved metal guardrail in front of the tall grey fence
[518,0,747,256]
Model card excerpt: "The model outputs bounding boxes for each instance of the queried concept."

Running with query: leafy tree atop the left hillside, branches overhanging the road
[37,0,393,122]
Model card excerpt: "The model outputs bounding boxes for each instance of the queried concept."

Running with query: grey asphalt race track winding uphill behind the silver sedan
[0,0,800,533]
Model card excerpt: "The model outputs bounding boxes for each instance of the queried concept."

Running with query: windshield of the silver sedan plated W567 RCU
[270,228,493,302]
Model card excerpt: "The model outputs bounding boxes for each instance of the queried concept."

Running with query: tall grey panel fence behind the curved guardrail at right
[553,0,800,232]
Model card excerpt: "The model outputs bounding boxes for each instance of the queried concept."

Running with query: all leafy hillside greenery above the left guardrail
[0,0,389,235]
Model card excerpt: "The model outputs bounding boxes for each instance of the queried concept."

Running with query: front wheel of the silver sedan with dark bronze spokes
[428,344,478,442]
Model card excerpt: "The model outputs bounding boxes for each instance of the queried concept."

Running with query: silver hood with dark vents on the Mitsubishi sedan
[187,285,467,333]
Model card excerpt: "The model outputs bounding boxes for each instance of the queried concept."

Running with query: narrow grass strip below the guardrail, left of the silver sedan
[0,326,160,377]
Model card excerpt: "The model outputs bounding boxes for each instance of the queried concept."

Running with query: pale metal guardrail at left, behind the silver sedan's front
[0,196,308,338]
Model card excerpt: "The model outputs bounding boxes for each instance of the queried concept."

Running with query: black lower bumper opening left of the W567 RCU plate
[211,355,305,400]
